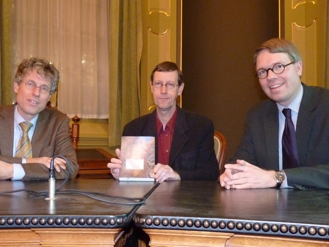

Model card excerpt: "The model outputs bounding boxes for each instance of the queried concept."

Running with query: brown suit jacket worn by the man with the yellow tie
[0,105,79,181]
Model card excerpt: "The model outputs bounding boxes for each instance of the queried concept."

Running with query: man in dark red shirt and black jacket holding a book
[108,62,219,182]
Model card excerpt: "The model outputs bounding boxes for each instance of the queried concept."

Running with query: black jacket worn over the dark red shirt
[123,108,219,180]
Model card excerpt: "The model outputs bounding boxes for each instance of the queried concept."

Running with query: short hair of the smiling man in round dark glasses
[254,38,302,64]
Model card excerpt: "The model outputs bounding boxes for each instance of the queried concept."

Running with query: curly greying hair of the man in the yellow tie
[14,57,59,94]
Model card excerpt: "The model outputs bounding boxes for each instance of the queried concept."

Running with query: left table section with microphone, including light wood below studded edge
[0,179,158,246]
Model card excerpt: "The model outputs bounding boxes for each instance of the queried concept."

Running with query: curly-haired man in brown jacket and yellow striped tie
[0,58,79,180]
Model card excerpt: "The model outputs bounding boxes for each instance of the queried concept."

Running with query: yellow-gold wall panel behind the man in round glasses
[279,0,329,87]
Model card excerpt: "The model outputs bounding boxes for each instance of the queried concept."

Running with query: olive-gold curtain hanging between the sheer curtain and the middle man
[109,0,143,146]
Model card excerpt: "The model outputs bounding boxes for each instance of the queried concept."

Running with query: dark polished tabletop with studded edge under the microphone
[0,179,154,228]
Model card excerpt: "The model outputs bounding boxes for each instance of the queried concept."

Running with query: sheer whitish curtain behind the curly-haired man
[12,0,109,119]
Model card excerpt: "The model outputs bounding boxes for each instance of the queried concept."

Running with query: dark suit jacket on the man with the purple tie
[230,84,329,189]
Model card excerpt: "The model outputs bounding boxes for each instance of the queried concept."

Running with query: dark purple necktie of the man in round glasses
[282,108,299,169]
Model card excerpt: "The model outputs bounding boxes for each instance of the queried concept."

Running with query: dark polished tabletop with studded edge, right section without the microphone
[134,181,329,240]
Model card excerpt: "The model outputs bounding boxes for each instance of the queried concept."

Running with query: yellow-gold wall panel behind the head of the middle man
[140,0,182,115]
